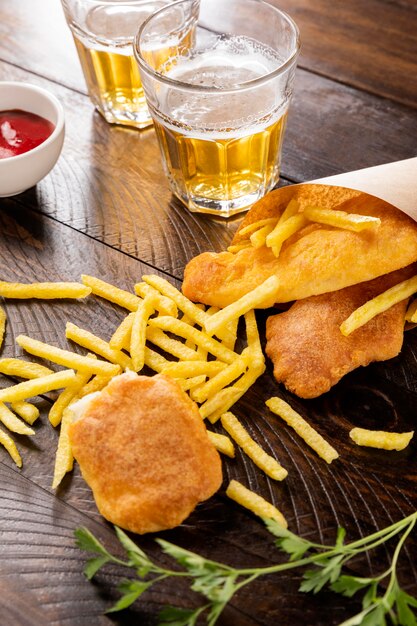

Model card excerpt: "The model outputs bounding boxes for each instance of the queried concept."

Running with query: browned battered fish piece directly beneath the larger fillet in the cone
[266,264,417,398]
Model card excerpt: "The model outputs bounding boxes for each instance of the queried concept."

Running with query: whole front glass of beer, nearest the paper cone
[134,0,299,217]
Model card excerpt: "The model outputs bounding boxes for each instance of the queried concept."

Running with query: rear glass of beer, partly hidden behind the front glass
[62,0,173,128]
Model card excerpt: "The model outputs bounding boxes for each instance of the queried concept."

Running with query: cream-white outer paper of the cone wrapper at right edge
[310,157,417,221]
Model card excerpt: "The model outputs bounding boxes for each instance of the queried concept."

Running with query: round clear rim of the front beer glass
[133,0,301,94]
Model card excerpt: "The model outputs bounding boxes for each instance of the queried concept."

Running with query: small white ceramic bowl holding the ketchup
[0,82,65,197]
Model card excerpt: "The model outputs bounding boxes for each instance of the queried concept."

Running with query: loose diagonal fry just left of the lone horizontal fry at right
[265,398,339,463]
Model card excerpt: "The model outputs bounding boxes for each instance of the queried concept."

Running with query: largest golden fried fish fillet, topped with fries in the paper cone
[182,184,417,308]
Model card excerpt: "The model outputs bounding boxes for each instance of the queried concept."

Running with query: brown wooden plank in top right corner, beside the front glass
[273,0,417,108]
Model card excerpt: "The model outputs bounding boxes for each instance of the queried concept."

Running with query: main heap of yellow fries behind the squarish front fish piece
[0,275,266,478]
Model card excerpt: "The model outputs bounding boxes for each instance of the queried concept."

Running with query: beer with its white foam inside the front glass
[146,37,287,215]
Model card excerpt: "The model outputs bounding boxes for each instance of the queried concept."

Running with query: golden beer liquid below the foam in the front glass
[155,114,286,208]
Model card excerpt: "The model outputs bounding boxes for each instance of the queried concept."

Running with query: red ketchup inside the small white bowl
[0,109,55,159]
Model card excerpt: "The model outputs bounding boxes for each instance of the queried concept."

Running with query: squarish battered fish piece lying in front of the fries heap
[69,373,222,534]
